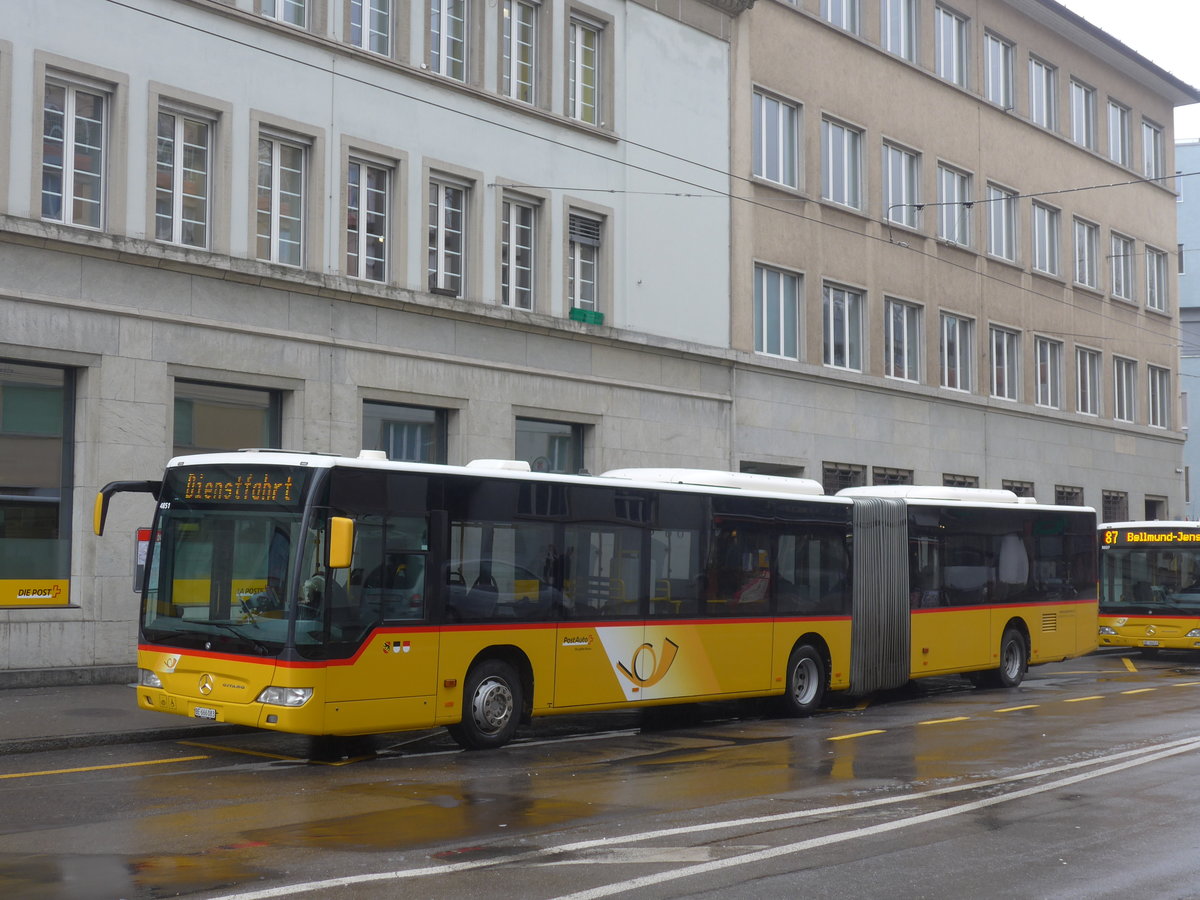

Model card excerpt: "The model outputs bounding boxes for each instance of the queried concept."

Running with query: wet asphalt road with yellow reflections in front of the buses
[0,653,1200,900]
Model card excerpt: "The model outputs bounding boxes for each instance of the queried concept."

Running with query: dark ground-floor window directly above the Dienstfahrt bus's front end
[174,380,282,456]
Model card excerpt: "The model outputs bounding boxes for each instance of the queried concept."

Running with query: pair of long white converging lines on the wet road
[204,737,1200,900]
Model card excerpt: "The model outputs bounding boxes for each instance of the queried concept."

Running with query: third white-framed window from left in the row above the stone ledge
[257,137,307,265]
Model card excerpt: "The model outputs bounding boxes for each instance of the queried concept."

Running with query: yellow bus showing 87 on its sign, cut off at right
[1099,521,1200,653]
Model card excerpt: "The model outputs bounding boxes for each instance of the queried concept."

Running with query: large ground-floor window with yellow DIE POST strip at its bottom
[0,360,74,607]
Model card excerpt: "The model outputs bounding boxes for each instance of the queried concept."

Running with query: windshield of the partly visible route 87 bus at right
[1100,546,1200,616]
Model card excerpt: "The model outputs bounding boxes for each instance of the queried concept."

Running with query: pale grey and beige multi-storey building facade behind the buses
[0,0,1198,682]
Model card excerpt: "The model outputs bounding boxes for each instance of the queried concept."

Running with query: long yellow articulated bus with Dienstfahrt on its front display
[95,450,1097,749]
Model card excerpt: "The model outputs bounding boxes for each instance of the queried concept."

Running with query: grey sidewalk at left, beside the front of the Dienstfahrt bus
[0,684,244,755]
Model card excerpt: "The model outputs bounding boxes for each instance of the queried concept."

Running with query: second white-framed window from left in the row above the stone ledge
[155,110,212,247]
